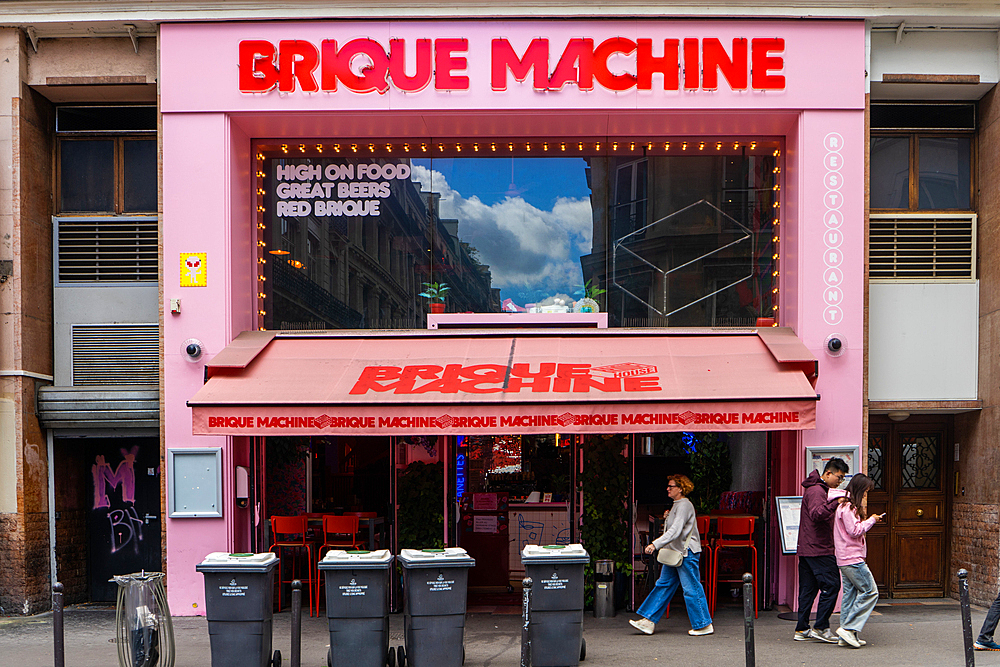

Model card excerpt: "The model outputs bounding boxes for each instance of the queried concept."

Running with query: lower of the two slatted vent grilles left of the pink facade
[73,324,160,387]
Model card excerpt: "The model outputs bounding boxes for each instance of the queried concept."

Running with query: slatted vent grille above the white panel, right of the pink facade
[868,213,976,280]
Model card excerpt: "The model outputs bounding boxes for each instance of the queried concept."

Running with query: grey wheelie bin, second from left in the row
[319,549,396,667]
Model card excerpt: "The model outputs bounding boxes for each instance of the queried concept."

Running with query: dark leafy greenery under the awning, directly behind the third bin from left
[396,461,444,549]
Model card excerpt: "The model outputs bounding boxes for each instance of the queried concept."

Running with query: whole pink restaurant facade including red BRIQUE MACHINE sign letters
[160,20,867,615]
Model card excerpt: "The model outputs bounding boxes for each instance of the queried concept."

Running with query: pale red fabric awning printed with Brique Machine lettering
[188,328,818,435]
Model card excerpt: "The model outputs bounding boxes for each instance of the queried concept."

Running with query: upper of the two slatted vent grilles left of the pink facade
[58,217,158,283]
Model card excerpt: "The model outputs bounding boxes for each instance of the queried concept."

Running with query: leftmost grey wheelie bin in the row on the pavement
[195,552,281,667]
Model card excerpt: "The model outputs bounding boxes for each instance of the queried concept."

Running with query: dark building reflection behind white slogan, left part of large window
[263,157,500,329]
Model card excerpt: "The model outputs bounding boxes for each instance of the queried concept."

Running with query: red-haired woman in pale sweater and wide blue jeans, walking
[629,475,715,636]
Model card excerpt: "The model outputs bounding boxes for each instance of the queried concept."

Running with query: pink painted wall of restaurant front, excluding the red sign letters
[160,21,865,615]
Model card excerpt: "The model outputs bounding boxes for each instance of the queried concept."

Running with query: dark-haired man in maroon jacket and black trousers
[795,458,848,644]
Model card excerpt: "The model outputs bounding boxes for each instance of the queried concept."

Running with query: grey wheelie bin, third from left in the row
[396,547,476,667]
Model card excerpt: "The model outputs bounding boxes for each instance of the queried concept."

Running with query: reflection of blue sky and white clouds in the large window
[412,157,593,306]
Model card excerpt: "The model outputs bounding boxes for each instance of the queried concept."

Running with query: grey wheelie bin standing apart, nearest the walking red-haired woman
[521,544,590,667]
